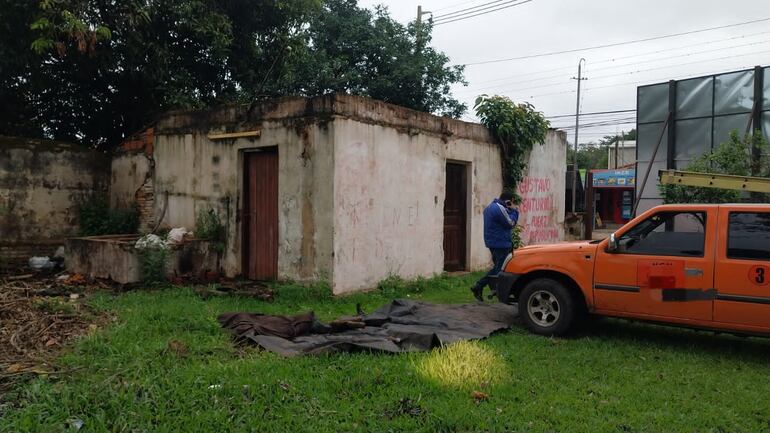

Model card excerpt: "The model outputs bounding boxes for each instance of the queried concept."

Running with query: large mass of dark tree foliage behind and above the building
[0,0,465,145]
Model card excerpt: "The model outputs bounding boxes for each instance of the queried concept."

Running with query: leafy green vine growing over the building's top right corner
[475,95,550,195]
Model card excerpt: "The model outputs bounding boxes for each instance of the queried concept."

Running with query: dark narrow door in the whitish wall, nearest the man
[444,163,467,272]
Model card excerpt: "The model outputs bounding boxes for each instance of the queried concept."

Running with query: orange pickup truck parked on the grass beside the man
[495,204,770,336]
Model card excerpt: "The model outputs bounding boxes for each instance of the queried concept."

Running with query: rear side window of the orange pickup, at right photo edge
[727,212,770,261]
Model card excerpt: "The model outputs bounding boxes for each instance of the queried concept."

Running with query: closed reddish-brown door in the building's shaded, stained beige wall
[243,150,278,280]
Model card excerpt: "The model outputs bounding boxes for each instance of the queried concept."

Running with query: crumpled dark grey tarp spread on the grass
[218,299,518,356]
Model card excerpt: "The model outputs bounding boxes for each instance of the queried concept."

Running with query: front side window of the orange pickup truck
[617,212,706,257]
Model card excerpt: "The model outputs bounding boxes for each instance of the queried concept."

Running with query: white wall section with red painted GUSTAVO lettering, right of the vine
[519,130,567,245]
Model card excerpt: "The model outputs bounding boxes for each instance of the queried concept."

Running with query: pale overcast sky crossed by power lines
[359,0,770,143]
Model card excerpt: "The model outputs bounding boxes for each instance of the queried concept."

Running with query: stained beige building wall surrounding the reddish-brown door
[154,113,333,280]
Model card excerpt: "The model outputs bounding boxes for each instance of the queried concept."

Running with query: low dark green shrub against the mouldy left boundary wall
[78,195,139,236]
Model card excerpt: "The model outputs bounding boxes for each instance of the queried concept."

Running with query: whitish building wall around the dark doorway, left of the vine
[333,119,501,294]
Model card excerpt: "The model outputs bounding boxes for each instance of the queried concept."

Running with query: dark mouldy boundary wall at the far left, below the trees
[0,137,109,264]
